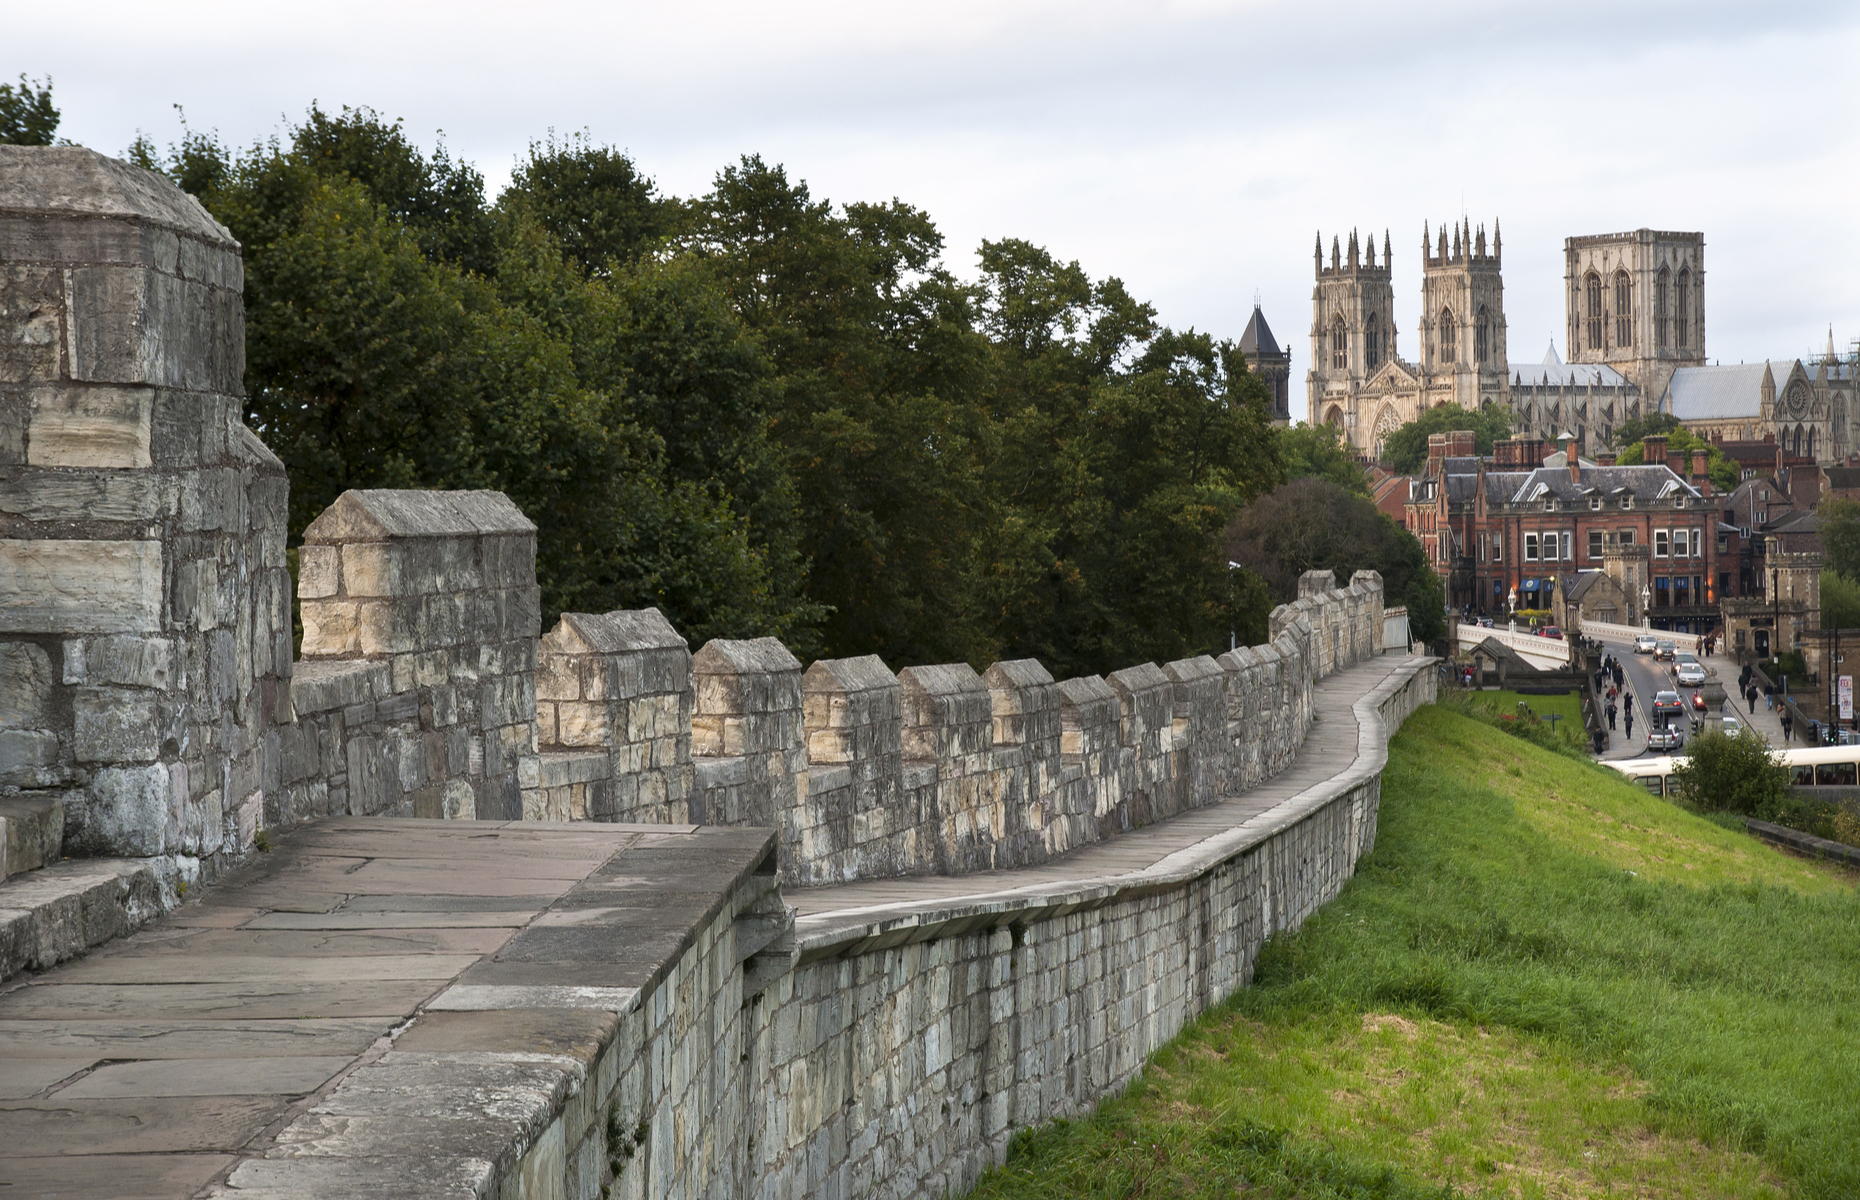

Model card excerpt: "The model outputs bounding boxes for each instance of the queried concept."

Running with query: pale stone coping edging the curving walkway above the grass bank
[794,657,1438,962]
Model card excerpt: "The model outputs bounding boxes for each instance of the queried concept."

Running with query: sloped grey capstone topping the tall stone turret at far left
[0,145,238,251]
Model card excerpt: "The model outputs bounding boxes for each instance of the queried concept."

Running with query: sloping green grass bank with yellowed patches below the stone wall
[977,705,1860,1200]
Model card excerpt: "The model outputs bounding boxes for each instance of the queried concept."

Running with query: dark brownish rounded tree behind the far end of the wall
[1224,478,1445,642]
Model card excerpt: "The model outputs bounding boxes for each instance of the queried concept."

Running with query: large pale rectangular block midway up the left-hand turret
[0,538,162,633]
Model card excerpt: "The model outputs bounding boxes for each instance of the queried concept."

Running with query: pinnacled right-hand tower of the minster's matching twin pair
[1419,221,1510,409]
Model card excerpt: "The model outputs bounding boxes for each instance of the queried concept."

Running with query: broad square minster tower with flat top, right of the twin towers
[1562,229,1706,404]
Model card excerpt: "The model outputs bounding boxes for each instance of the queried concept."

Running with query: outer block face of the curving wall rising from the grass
[546,659,1436,1200]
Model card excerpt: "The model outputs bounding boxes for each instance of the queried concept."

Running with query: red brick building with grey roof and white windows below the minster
[1406,432,1722,633]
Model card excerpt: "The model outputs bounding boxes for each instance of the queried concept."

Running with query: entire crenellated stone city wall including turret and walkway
[0,147,1436,1200]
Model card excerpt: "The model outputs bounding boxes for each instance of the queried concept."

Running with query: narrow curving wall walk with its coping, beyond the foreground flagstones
[789,657,1438,962]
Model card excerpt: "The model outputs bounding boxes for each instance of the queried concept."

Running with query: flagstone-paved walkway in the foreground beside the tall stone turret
[0,817,776,1200]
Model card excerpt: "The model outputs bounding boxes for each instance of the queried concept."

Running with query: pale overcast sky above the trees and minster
[18,0,1860,411]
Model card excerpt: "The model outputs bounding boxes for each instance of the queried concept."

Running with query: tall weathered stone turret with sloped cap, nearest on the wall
[0,147,292,869]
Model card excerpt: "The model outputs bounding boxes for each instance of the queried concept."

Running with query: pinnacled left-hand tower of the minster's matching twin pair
[1306,229,1395,445]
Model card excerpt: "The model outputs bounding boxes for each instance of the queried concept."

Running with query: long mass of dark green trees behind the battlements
[105,98,1285,675]
